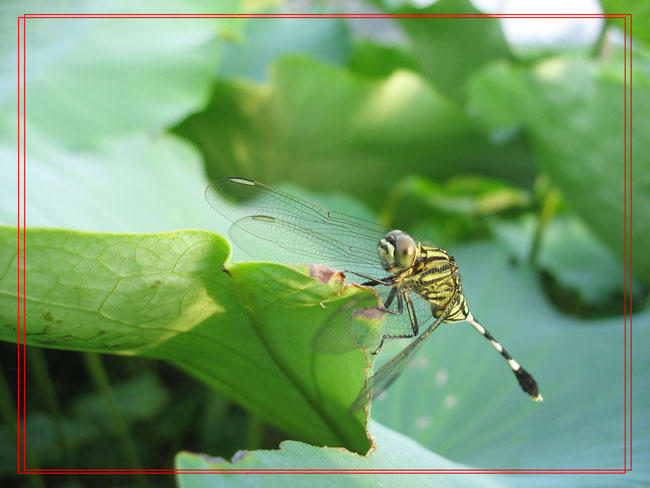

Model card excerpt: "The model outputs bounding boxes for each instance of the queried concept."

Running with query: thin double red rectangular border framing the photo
[17,13,632,474]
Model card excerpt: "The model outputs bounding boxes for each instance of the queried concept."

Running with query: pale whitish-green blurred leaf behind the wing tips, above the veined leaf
[0,131,218,232]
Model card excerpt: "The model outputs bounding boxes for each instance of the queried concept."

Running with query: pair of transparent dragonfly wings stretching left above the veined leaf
[205,178,388,282]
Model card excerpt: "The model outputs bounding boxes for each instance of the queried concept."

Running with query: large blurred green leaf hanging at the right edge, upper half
[528,60,650,282]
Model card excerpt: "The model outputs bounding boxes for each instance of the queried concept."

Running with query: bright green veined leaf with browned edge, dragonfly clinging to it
[0,227,377,452]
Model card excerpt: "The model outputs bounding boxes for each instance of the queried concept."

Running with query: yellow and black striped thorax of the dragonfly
[402,243,469,322]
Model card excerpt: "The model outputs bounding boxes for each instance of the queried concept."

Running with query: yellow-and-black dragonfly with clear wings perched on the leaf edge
[205,177,543,410]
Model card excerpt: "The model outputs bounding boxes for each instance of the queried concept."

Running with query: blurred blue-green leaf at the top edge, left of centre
[219,18,350,81]
